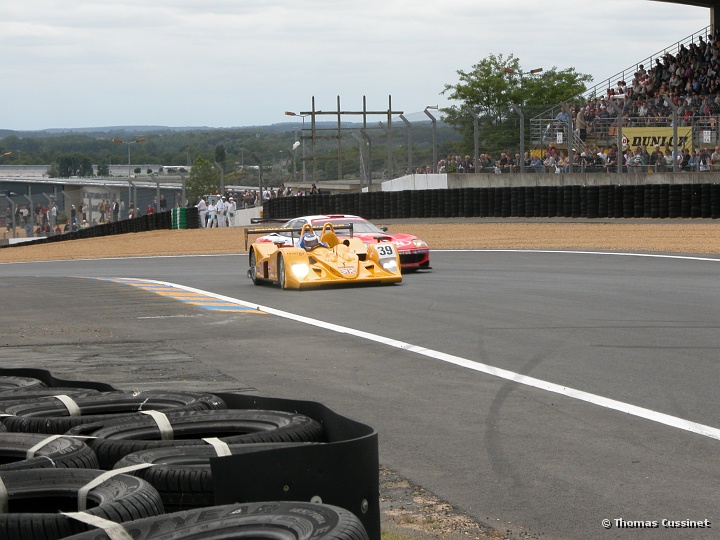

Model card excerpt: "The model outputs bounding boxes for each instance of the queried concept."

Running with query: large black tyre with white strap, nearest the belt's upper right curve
[68,409,325,469]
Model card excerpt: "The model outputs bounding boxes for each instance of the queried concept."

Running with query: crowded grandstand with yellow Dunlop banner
[530,0,720,172]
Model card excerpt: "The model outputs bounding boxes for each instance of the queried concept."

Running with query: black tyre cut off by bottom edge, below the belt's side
[66,502,368,540]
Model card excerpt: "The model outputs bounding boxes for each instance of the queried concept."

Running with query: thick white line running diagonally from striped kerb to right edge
[132,274,720,440]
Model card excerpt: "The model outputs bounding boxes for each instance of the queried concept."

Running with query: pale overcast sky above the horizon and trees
[0,0,710,130]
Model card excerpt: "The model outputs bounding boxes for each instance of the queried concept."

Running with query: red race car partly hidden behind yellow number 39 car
[255,214,430,272]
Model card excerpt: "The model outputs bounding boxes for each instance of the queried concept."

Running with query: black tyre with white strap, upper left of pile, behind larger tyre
[0,391,226,434]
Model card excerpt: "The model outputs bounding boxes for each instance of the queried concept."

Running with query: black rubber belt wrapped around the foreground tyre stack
[0,368,380,540]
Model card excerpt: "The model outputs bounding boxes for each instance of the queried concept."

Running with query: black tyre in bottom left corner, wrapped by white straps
[0,469,163,540]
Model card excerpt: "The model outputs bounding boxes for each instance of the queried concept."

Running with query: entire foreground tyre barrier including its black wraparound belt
[0,370,382,540]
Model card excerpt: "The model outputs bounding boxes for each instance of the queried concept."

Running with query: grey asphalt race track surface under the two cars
[0,251,720,538]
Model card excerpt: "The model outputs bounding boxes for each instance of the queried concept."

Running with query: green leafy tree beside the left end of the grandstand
[441,54,592,154]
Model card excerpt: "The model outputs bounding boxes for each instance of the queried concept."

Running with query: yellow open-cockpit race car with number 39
[245,223,402,289]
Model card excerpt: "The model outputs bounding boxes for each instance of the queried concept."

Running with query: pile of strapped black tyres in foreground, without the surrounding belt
[0,376,368,540]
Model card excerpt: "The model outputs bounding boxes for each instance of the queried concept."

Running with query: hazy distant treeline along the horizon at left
[0,122,466,178]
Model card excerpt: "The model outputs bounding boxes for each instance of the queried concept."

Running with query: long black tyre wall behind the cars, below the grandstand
[263,183,720,220]
